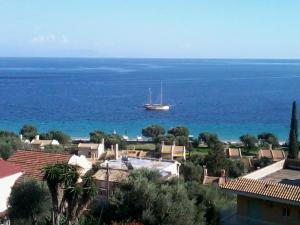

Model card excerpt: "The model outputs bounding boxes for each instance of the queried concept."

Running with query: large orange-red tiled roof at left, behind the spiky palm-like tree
[8,150,71,180]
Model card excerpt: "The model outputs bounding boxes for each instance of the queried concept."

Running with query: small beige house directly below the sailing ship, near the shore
[160,141,186,160]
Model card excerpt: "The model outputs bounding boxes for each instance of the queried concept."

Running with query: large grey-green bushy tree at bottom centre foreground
[109,170,203,225]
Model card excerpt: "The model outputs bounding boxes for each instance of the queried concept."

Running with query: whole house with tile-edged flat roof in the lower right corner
[220,159,300,225]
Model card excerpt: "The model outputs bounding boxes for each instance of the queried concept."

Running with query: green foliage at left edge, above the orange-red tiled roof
[0,131,22,159]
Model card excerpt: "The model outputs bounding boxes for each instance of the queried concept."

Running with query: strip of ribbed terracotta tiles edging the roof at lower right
[221,178,300,203]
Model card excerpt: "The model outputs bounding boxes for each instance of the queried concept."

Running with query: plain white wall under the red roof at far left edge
[0,172,22,212]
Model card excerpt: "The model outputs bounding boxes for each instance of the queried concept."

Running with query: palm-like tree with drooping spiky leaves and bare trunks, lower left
[43,163,97,225]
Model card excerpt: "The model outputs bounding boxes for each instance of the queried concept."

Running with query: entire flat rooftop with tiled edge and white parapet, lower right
[221,159,300,205]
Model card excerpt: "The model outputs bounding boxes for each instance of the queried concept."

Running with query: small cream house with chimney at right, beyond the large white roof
[78,139,104,160]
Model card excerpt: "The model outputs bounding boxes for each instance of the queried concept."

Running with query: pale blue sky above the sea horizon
[0,0,300,58]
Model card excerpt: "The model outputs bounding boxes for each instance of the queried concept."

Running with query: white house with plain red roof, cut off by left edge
[0,159,23,225]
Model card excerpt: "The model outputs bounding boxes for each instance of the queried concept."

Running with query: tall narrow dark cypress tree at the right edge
[288,101,299,159]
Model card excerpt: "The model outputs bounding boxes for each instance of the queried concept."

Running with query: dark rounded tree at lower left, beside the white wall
[8,180,50,225]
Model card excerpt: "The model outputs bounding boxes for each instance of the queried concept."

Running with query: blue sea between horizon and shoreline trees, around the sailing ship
[0,58,300,140]
